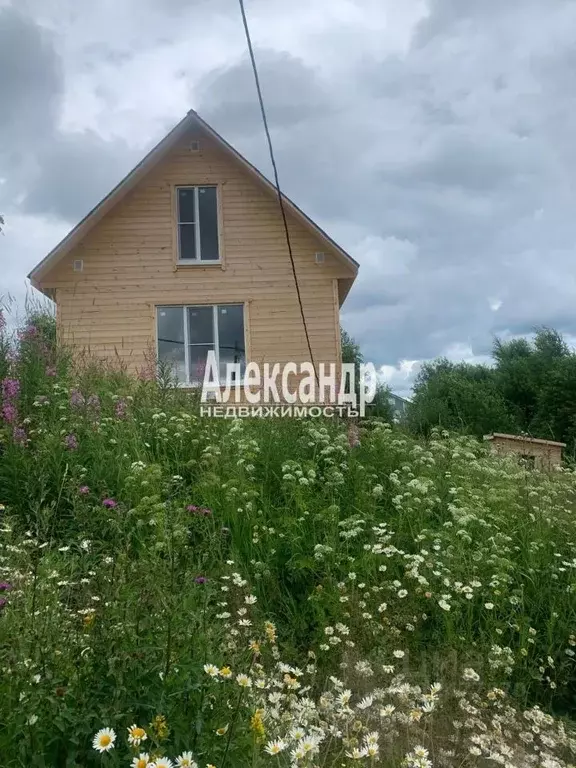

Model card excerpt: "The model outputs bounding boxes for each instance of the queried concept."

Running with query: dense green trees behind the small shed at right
[408,328,576,453]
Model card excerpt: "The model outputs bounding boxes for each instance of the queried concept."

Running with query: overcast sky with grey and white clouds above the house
[0,0,576,392]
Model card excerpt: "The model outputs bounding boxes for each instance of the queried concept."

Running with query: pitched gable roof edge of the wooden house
[28,109,360,290]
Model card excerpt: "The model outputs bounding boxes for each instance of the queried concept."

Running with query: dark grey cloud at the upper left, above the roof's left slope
[0,7,135,223]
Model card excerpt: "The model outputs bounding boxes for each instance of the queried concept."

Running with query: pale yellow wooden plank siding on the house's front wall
[42,131,353,378]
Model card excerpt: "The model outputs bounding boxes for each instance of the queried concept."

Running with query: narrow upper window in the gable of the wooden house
[176,187,220,264]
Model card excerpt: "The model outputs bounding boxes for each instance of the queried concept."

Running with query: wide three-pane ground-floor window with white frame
[156,304,246,386]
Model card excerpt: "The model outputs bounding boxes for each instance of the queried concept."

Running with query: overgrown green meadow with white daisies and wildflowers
[0,308,576,768]
